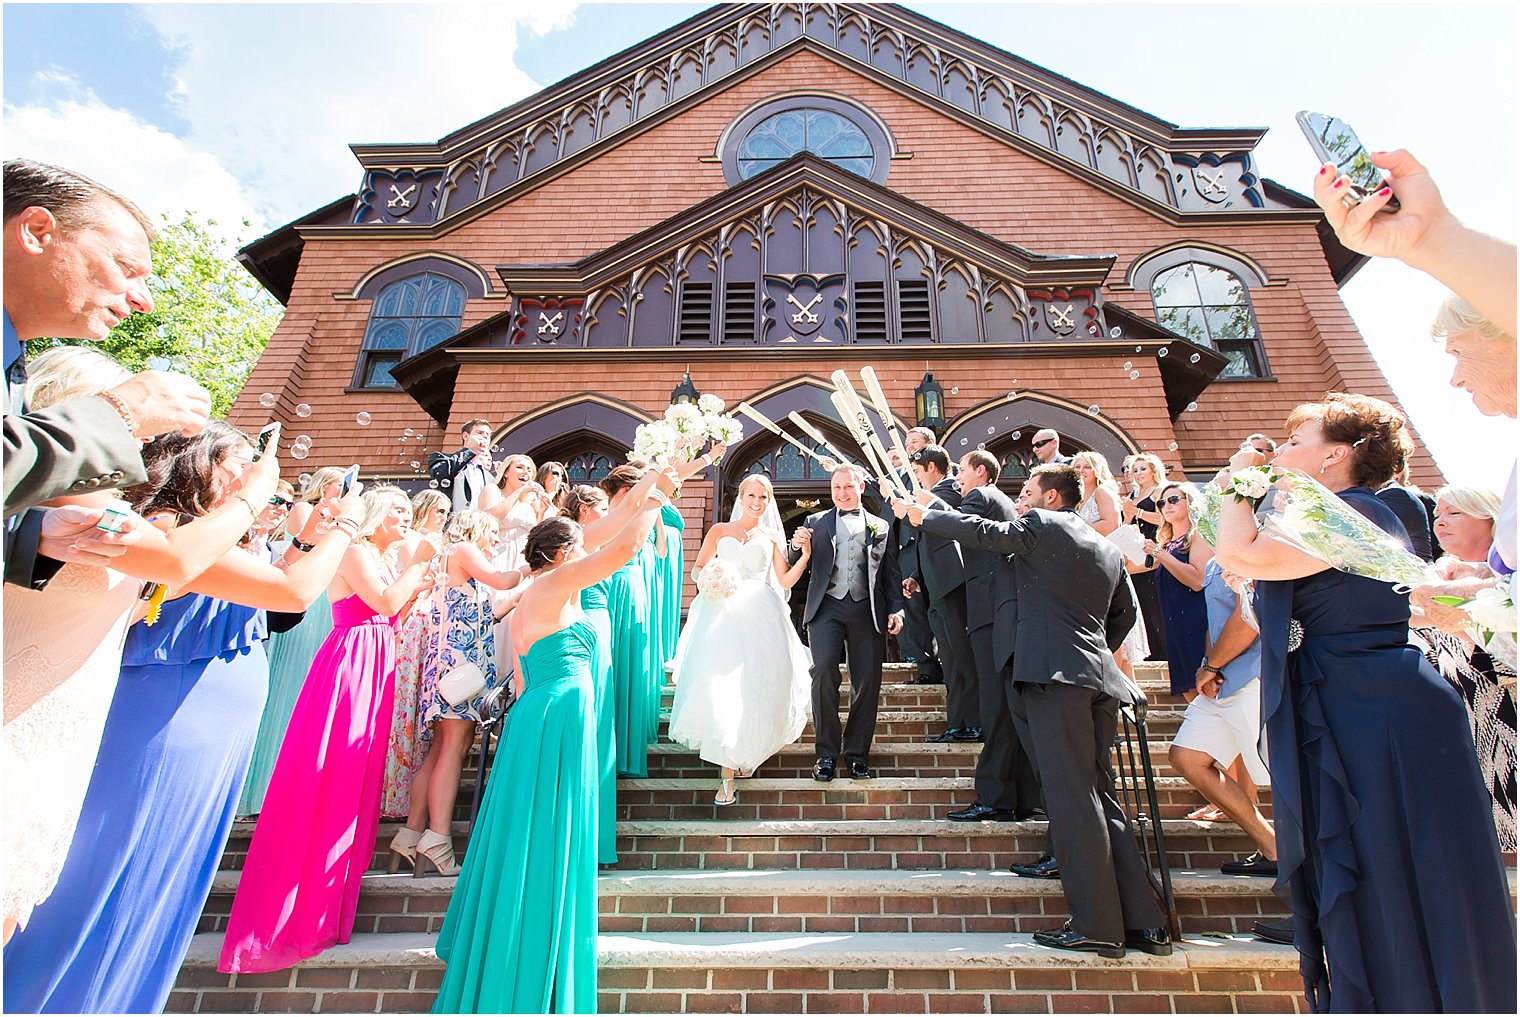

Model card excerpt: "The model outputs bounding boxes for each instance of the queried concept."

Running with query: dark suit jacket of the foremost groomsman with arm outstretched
[924,509,1137,701]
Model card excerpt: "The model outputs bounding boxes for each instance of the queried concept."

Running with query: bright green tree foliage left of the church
[27,213,284,417]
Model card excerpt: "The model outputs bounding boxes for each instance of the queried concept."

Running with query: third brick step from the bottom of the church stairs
[617,819,1270,871]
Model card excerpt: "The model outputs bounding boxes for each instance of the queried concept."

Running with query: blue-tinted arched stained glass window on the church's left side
[354,272,465,388]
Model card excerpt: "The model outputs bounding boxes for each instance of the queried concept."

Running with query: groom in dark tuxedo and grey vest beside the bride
[787,465,903,781]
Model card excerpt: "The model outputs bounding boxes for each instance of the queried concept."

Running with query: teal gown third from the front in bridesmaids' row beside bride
[606,543,660,777]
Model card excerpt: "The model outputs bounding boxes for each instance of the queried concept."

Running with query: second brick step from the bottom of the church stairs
[198,870,1284,933]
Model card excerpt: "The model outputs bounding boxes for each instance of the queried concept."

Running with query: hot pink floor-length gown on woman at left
[217,594,395,971]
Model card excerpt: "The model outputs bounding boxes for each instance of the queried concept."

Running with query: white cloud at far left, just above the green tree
[5,71,266,237]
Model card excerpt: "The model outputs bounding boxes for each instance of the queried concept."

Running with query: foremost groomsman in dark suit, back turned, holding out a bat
[894,464,1172,958]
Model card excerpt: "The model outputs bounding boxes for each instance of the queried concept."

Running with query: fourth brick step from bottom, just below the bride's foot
[617,766,1271,819]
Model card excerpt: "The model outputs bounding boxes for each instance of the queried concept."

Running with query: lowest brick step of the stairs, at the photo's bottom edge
[166,932,1303,1014]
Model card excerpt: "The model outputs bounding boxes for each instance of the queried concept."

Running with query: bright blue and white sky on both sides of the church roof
[0,0,1520,483]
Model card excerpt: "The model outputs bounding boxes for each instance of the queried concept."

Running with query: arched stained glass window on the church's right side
[1151,261,1263,379]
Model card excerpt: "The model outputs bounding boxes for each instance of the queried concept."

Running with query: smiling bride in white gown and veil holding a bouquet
[670,473,813,806]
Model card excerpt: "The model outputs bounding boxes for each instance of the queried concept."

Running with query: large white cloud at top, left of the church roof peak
[141,0,579,223]
